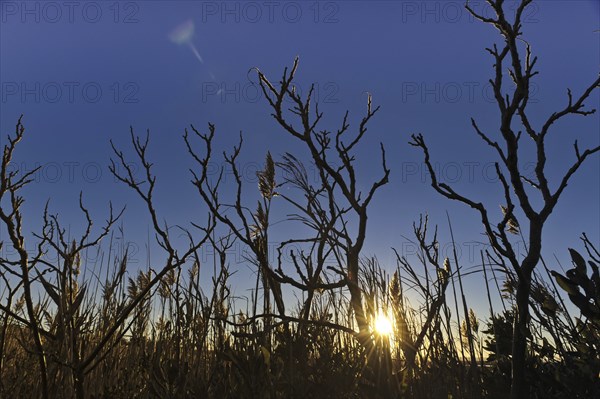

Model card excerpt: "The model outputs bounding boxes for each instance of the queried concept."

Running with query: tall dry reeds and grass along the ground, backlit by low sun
[0,223,599,398]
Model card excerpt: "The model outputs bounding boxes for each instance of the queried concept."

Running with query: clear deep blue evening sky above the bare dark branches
[0,0,600,318]
